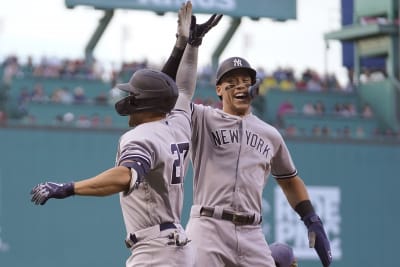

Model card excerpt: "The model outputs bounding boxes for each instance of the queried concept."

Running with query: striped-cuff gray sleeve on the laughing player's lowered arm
[271,133,297,179]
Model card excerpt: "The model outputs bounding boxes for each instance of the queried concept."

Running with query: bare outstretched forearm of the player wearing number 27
[74,166,131,196]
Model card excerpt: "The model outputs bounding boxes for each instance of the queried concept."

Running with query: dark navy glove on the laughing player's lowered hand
[302,212,332,267]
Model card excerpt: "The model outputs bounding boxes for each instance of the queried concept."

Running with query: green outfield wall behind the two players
[0,127,400,267]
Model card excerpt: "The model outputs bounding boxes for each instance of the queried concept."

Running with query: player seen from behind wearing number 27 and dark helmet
[31,2,220,267]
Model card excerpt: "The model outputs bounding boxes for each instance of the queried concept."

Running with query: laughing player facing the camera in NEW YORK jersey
[173,48,332,267]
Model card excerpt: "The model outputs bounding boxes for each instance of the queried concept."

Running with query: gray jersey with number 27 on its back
[116,110,190,233]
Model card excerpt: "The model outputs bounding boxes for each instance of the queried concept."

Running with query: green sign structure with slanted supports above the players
[65,0,297,69]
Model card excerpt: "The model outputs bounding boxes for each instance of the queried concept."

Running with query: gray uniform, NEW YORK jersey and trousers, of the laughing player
[186,104,297,267]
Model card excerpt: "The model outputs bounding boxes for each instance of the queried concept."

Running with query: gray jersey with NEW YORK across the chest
[192,104,297,214]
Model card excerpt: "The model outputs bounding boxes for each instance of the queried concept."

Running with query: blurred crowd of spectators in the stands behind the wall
[0,53,400,140]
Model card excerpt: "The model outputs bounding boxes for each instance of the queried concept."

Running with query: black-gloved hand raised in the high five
[188,14,223,47]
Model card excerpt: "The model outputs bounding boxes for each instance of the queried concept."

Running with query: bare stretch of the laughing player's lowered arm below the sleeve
[278,176,310,209]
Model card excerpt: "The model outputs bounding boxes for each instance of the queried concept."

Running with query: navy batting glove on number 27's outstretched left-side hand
[31,182,75,205]
